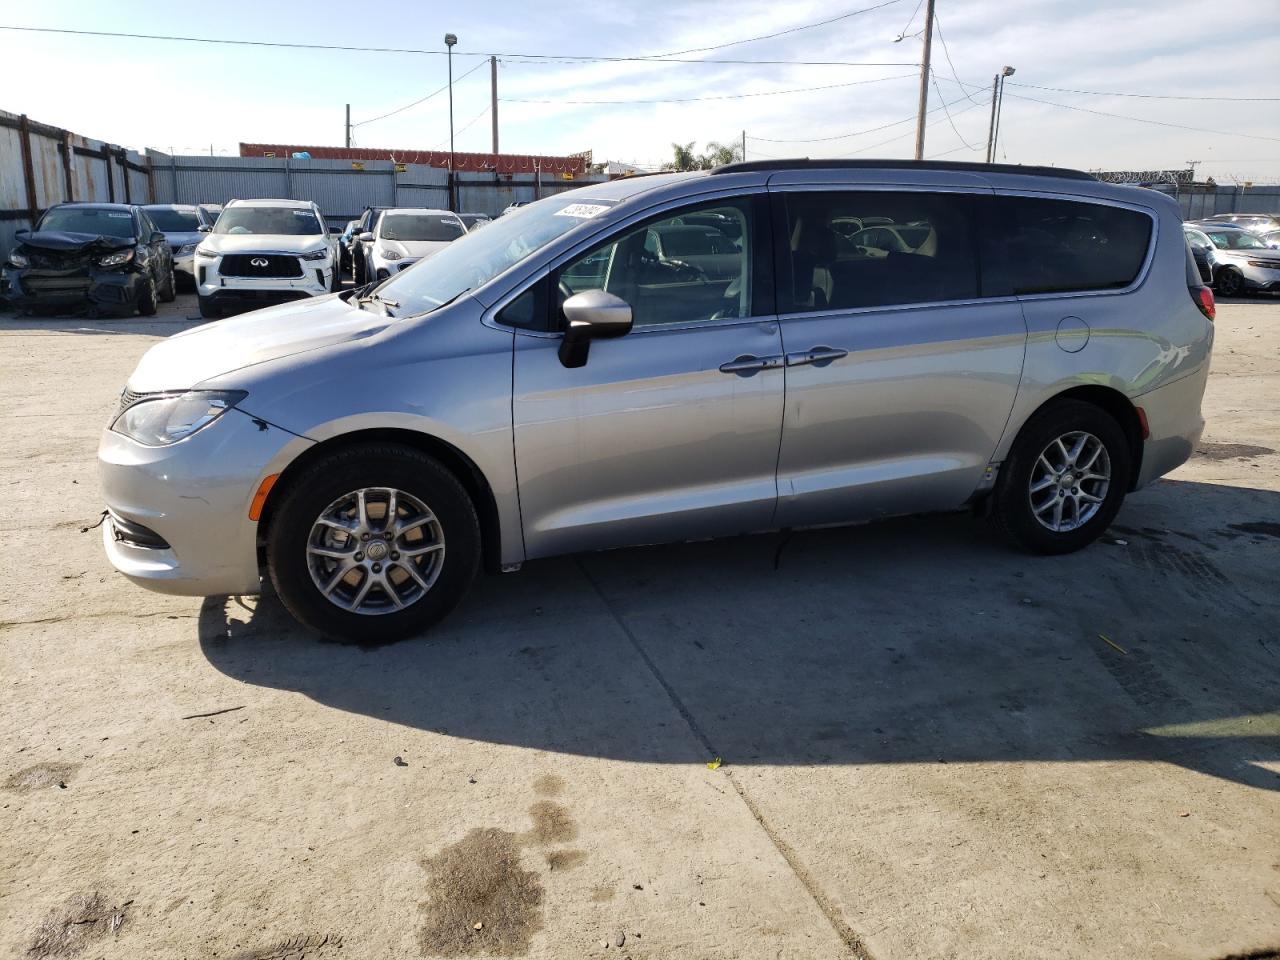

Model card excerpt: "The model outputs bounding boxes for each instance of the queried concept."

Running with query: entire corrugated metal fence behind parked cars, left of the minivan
[0,110,608,259]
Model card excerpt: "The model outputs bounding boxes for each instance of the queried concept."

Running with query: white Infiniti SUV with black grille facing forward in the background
[195,200,339,317]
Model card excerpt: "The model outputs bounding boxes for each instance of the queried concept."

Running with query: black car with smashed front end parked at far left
[0,204,177,316]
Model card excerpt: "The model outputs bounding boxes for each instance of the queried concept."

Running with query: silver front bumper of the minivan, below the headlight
[97,410,311,596]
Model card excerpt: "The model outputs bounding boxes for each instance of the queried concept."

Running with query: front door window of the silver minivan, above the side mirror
[556,197,764,329]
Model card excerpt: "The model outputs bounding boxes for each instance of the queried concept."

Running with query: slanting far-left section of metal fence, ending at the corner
[0,110,151,257]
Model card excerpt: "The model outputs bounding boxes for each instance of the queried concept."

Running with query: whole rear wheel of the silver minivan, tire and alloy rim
[993,399,1133,554]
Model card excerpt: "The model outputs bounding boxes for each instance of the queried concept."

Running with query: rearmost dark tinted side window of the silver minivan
[979,197,1152,297]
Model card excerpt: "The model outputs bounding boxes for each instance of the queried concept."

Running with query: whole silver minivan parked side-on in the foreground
[99,160,1213,641]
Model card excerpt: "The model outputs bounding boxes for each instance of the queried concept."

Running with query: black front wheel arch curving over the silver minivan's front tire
[259,428,502,573]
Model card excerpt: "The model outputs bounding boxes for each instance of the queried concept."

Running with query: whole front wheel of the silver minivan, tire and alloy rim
[268,444,480,643]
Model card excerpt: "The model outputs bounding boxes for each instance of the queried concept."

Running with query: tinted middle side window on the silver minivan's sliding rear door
[780,192,978,312]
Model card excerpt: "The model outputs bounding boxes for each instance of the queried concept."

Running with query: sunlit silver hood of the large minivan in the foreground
[128,296,394,393]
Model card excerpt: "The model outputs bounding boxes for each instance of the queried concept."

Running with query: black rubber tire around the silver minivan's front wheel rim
[266,443,480,644]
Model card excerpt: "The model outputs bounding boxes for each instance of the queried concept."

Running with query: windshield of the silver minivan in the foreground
[378,191,614,315]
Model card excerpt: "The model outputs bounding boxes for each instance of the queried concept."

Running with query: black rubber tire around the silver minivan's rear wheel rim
[992,399,1133,554]
